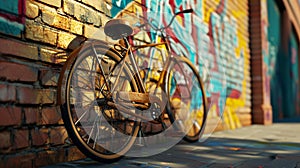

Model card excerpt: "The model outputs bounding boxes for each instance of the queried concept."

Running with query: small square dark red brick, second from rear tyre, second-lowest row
[31,128,49,146]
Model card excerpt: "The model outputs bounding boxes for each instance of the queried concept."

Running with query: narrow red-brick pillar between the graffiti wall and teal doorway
[249,0,272,124]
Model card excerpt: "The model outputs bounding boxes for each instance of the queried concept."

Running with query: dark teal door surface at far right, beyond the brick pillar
[264,0,300,121]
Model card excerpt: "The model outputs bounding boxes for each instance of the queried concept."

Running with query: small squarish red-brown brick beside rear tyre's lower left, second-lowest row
[50,126,68,145]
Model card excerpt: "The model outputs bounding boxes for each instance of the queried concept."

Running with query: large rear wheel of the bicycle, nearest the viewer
[60,45,140,162]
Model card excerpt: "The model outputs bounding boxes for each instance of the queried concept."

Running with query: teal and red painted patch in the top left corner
[0,0,25,37]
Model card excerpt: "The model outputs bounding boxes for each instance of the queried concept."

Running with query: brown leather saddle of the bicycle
[104,19,133,40]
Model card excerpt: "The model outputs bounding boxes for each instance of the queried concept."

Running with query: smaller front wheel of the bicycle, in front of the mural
[164,57,207,142]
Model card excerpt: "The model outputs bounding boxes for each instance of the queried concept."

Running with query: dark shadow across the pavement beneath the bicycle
[43,137,300,168]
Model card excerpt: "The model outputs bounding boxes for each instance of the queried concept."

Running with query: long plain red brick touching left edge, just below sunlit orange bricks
[0,61,38,82]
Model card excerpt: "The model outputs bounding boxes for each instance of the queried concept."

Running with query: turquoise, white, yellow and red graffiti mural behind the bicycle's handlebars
[111,0,250,128]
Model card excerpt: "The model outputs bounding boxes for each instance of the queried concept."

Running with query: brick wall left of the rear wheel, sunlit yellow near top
[0,0,110,167]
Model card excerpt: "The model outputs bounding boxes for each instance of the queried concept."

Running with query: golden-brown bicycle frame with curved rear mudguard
[58,10,196,121]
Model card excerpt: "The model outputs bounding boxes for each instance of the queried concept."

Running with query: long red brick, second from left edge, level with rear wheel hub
[17,87,56,104]
